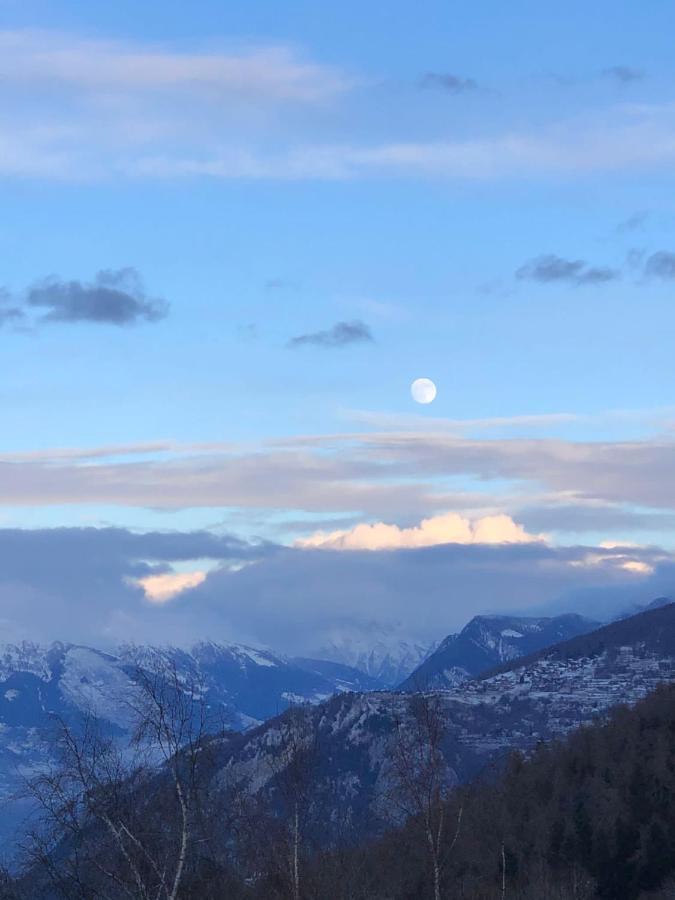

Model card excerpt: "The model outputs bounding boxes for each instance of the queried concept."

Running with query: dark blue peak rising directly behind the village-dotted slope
[400,614,600,691]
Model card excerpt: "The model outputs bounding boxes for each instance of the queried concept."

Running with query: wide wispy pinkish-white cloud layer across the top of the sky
[0,31,675,181]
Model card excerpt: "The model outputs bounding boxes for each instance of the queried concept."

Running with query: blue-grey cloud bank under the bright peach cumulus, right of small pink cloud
[166,544,675,655]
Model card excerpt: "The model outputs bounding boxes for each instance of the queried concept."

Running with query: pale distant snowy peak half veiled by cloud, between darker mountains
[312,625,436,687]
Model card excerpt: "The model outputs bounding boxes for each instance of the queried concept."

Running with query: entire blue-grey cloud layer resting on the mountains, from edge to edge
[0,528,675,655]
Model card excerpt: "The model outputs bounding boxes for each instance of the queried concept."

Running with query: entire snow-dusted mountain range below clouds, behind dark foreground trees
[0,599,675,856]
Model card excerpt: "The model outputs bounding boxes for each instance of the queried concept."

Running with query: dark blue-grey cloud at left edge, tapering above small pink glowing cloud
[0,528,276,644]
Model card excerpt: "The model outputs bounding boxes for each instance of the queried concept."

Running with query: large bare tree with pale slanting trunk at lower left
[26,660,214,900]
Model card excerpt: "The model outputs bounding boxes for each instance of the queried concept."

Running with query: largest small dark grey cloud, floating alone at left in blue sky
[26,268,168,326]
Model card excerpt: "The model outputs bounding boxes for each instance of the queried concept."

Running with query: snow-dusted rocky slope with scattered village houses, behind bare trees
[203,604,675,831]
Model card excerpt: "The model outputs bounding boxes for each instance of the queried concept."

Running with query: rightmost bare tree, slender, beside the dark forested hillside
[386,693,463,900]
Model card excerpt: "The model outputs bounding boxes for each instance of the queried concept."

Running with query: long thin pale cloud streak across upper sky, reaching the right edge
[128,118,675,181]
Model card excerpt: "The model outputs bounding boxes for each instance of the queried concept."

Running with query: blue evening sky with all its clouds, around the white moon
[0,0,675,652]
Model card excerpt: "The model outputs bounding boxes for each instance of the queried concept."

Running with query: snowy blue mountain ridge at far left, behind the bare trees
[0,642,379,839]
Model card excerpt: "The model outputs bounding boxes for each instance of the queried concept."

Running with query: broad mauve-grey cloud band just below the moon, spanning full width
[6,423,675,534]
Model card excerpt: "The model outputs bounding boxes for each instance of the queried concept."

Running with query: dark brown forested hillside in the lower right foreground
[304,685,675,900]
